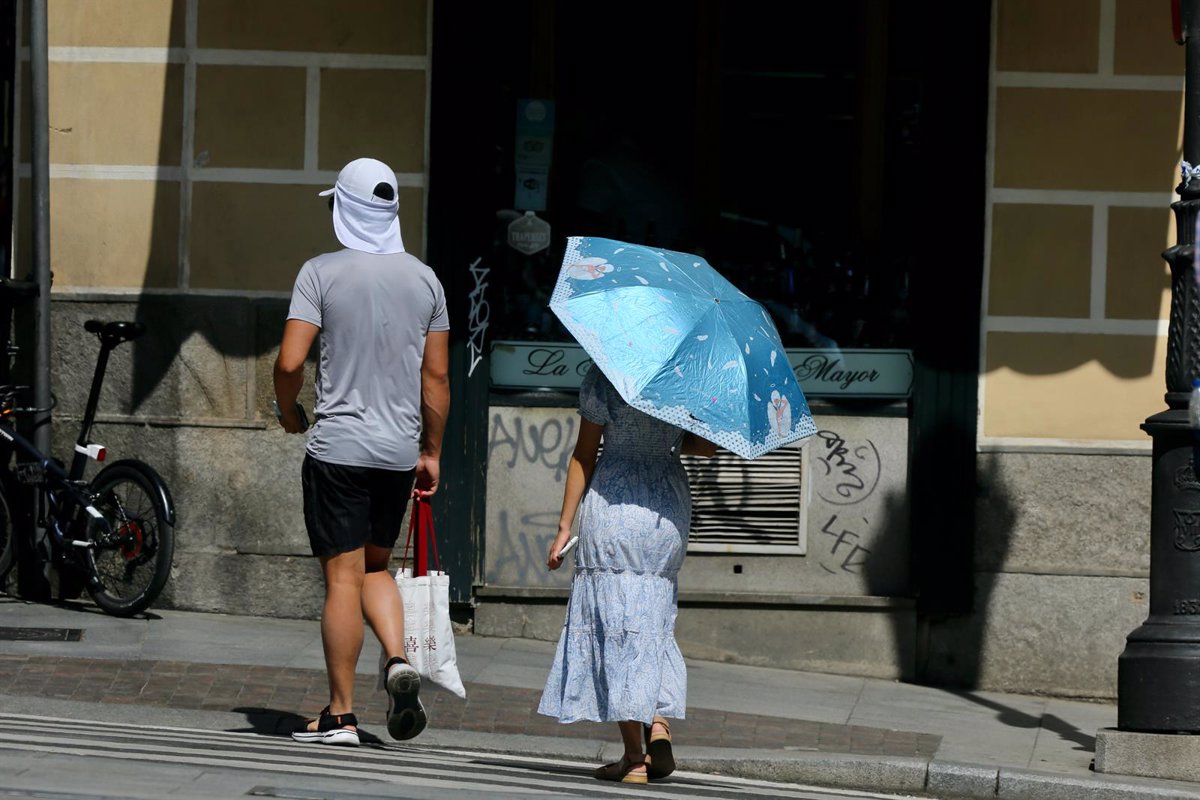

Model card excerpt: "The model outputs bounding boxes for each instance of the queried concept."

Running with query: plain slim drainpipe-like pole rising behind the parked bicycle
[29,0,50,452]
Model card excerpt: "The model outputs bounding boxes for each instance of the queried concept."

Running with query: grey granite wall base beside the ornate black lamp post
[917,452,1151,698]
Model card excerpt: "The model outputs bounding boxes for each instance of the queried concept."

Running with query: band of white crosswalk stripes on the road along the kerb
[0,714,907,800]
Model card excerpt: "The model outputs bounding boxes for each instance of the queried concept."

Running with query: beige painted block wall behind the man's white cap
[18,0,428,293]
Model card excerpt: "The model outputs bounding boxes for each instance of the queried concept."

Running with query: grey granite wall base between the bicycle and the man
[46,295,323,618]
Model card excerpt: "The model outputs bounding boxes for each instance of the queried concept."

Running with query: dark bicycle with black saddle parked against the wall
[0,278,175,616]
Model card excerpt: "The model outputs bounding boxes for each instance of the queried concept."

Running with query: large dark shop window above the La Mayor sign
[463,0,922,348]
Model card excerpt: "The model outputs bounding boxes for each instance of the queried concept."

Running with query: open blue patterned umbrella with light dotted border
[550,236,816,458]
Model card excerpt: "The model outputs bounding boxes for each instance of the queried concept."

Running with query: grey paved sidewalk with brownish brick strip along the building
[0,597,1200,800]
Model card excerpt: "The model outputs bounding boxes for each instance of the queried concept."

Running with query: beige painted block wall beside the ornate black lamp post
[979,0,1183,447]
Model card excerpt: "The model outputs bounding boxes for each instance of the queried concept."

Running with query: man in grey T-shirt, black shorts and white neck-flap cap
[275,158,450,745]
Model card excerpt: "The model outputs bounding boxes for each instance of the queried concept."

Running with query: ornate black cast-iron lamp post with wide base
[1117,0,1200,733]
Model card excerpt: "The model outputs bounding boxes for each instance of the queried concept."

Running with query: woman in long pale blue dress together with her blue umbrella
[538,237,816,783]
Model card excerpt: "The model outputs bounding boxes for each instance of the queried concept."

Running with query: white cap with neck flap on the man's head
[318,158,404,253]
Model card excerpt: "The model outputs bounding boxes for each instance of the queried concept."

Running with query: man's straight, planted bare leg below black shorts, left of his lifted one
[320,547,365,714]
